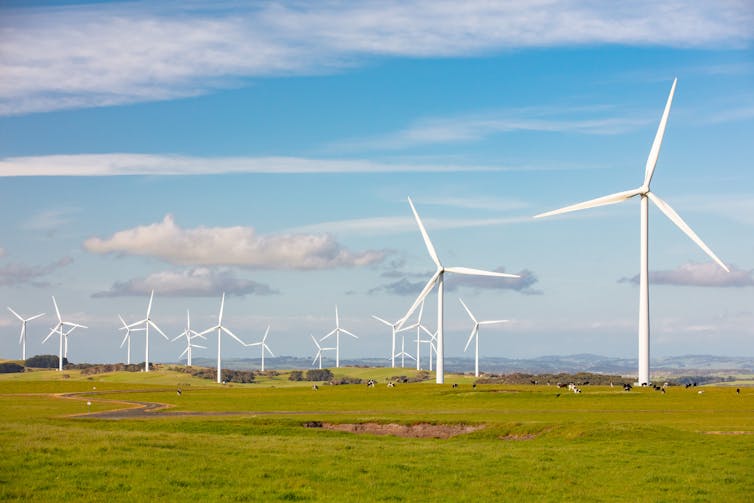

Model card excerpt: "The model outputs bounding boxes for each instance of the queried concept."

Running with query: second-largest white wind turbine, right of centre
[398,197,519,384]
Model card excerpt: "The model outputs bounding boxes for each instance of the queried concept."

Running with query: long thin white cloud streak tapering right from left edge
[0,153,505,176]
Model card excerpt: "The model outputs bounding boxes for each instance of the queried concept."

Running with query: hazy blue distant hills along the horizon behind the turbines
[188,354,754,376]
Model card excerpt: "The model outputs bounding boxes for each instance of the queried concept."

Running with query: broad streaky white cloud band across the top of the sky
[0,0,754,115]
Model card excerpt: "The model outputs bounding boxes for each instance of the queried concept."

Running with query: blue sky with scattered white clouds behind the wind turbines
[0,0,754,368]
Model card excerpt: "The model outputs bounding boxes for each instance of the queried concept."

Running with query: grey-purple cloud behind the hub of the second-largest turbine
[367,267,542,295]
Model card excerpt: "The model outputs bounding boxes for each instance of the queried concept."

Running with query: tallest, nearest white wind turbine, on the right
[534,79,729,385]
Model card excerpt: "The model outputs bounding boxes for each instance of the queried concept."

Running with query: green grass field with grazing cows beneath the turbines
[0,368,754,502]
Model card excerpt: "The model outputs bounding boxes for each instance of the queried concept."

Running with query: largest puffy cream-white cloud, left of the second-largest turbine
[84,215,387,269]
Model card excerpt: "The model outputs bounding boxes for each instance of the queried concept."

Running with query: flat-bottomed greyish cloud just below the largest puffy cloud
[92,267,279,298]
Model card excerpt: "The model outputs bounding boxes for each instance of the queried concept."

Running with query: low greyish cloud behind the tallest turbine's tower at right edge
[618,262,754,288]
